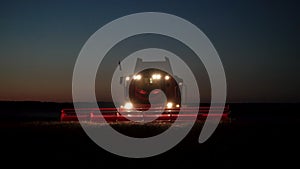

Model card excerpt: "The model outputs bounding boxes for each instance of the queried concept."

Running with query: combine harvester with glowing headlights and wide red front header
[60,58,230,122]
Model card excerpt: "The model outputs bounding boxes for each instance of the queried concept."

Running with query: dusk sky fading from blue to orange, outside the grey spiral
[0,0,300,102]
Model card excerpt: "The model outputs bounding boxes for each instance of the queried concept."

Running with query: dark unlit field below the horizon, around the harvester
[0,103,300,168]
